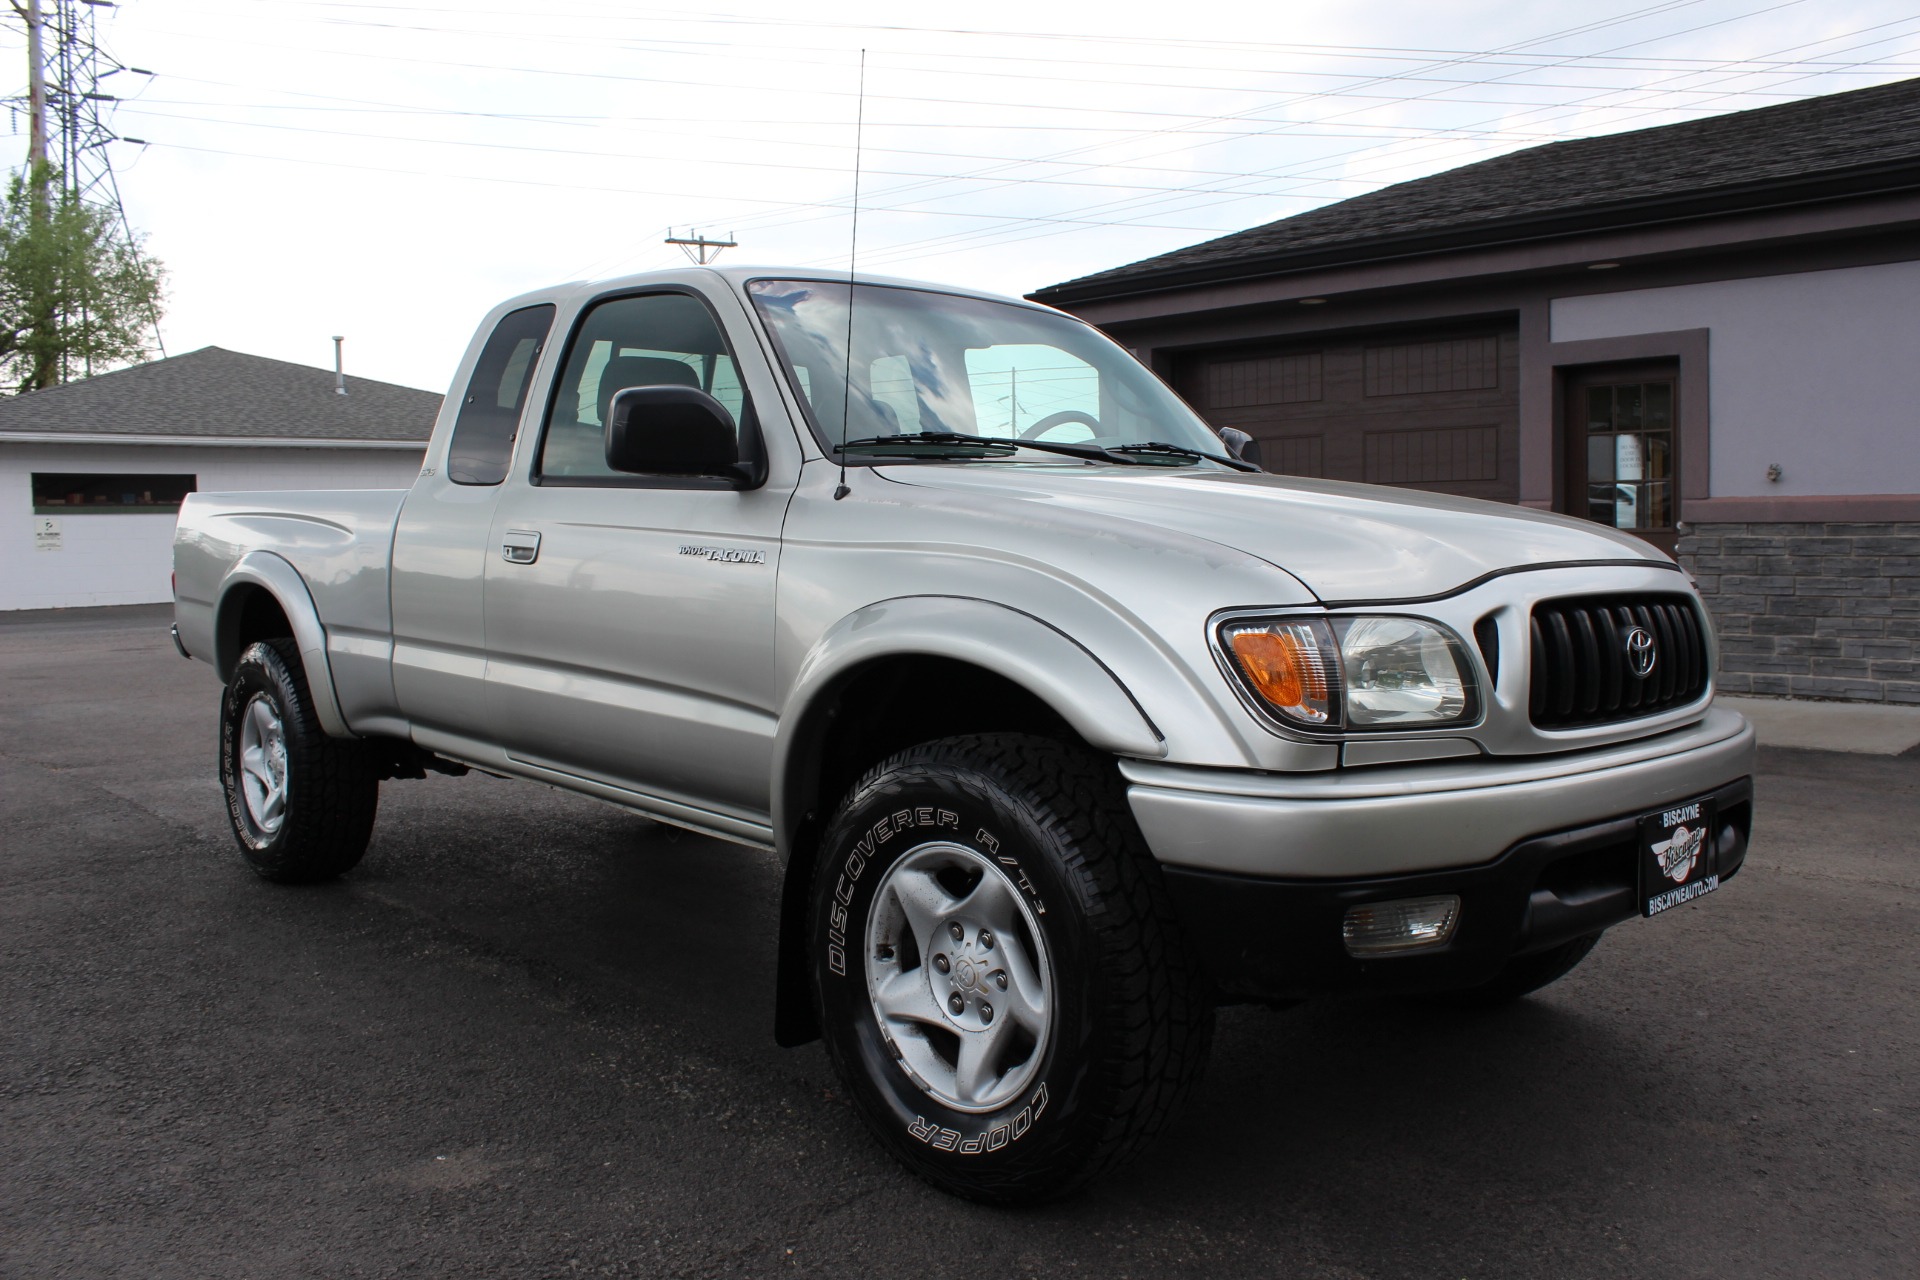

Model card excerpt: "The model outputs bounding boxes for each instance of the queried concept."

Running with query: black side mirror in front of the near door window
[607,384,766,489]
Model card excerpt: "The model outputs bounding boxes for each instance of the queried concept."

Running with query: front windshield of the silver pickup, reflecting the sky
[747,280,1225,457]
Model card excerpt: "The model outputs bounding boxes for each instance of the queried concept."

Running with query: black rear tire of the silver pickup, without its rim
[221,639,380,885]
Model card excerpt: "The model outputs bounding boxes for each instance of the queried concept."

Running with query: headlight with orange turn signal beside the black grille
[1219,616,1480,729]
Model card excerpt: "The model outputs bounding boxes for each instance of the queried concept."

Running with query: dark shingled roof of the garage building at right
[1031,79,1920,305]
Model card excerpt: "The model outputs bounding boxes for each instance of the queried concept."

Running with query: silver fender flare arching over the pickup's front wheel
[772,595,1167,858]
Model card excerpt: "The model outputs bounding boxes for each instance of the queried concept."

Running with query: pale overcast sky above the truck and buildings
[0,0,1920,391]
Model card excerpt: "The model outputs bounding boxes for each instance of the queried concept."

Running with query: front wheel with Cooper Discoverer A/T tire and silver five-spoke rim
[808,735,1212,1203]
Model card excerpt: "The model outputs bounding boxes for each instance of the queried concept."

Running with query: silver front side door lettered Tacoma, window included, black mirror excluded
[486,292,795,825]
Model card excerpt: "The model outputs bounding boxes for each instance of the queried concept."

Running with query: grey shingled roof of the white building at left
[0,347,442,443]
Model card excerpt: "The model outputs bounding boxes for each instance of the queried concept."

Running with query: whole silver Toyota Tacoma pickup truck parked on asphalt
[175,269,1755,1201]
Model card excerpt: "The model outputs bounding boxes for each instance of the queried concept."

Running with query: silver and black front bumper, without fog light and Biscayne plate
[1123,712,1755,1000]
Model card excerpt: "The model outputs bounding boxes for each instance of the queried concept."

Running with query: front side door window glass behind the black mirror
[538,294,747,480]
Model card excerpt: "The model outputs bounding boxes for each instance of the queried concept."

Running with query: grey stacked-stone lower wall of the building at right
[1680,522,1920,704]
